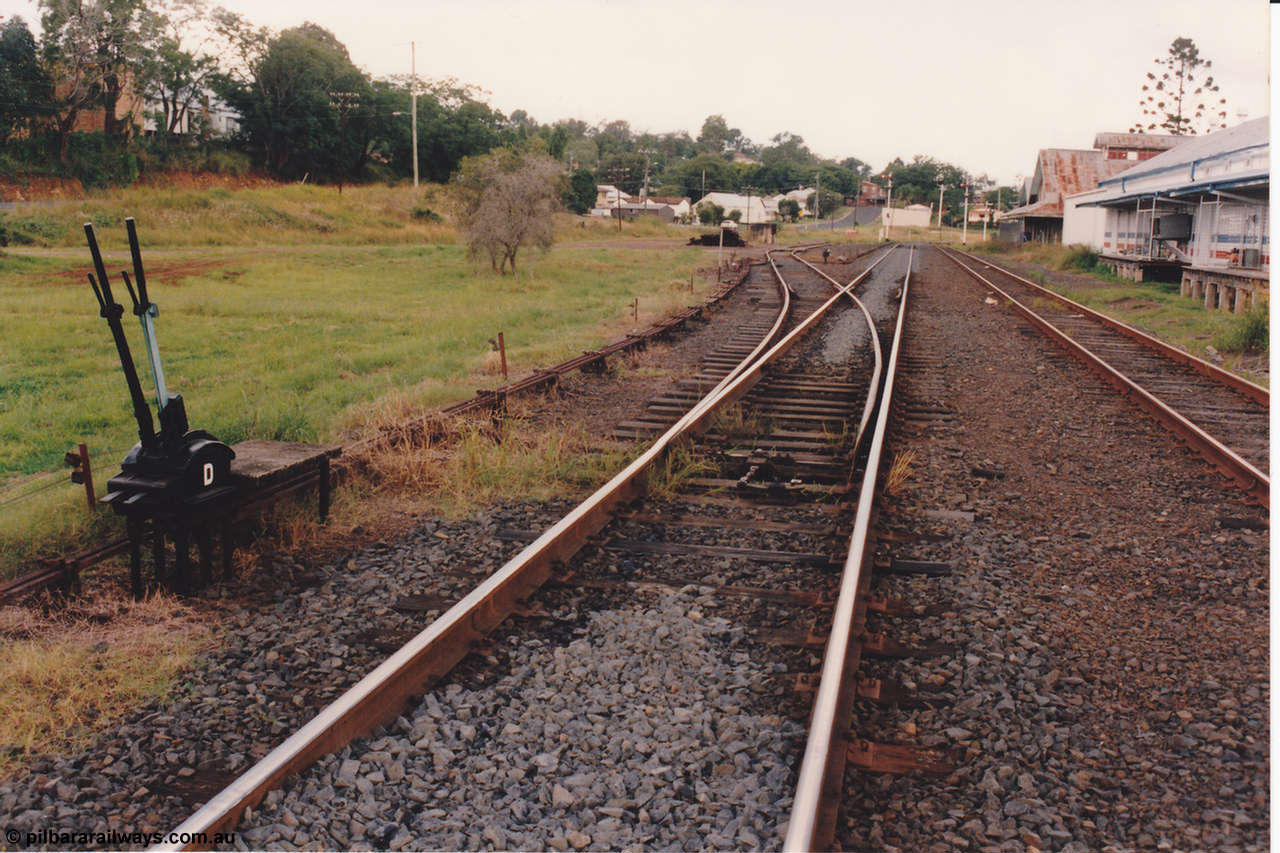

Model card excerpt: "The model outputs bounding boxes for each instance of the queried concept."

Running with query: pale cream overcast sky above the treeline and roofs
[0,0,1270,183]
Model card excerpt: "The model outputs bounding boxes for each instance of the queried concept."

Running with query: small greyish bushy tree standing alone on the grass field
[454,147,564,274]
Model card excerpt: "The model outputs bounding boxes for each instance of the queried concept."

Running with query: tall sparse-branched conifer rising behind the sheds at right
[1129,37,1226,136]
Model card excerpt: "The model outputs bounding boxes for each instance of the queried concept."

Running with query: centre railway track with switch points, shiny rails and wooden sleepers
[137,247,910,848]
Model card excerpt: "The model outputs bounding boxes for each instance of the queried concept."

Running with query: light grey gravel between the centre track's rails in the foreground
[242,588,804,850]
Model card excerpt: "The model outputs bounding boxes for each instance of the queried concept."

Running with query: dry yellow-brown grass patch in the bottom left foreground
[0,596,209,779]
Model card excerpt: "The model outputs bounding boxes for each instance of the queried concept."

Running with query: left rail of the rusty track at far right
[943,250,1271,508]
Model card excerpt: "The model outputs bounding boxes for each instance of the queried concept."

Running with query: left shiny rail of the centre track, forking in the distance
[160,242,892,850]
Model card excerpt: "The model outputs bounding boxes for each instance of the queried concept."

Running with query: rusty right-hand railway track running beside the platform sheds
[940,250,1271,506]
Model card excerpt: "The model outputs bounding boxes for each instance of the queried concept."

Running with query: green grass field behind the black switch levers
[0,181,714,576]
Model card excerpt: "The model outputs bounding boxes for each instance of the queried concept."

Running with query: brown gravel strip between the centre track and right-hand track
[837,242,1270,853]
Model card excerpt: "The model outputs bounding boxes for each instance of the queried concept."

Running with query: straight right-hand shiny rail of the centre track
[782,242,915,850]
